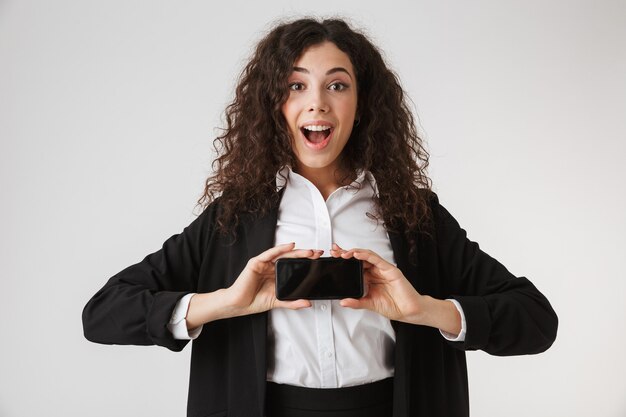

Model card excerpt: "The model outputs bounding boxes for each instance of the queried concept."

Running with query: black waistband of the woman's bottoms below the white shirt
[267,378,393,417]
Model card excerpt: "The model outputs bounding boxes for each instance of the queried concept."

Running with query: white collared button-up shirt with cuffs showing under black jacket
[168,168,465,388]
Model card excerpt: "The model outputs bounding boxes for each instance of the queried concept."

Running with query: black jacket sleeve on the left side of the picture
[82,204,215,351]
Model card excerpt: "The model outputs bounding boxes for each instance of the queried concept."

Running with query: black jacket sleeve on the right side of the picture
[432,196,558,356]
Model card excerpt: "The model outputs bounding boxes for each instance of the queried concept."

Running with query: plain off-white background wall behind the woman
[0,0,626,417]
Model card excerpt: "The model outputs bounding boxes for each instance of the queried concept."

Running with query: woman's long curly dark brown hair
[198,18,432,249]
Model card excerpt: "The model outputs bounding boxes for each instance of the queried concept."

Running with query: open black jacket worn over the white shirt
[83,194,557,417]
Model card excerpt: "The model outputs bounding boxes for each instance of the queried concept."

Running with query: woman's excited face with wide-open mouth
[282,42,357,176]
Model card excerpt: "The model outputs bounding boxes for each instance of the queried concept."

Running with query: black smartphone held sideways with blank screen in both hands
[276,258,363,300]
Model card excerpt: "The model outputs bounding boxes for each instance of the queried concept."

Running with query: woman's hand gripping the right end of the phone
[330,243,461,335]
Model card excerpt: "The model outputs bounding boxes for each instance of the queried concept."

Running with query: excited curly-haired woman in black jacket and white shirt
[83,19,557,417]
